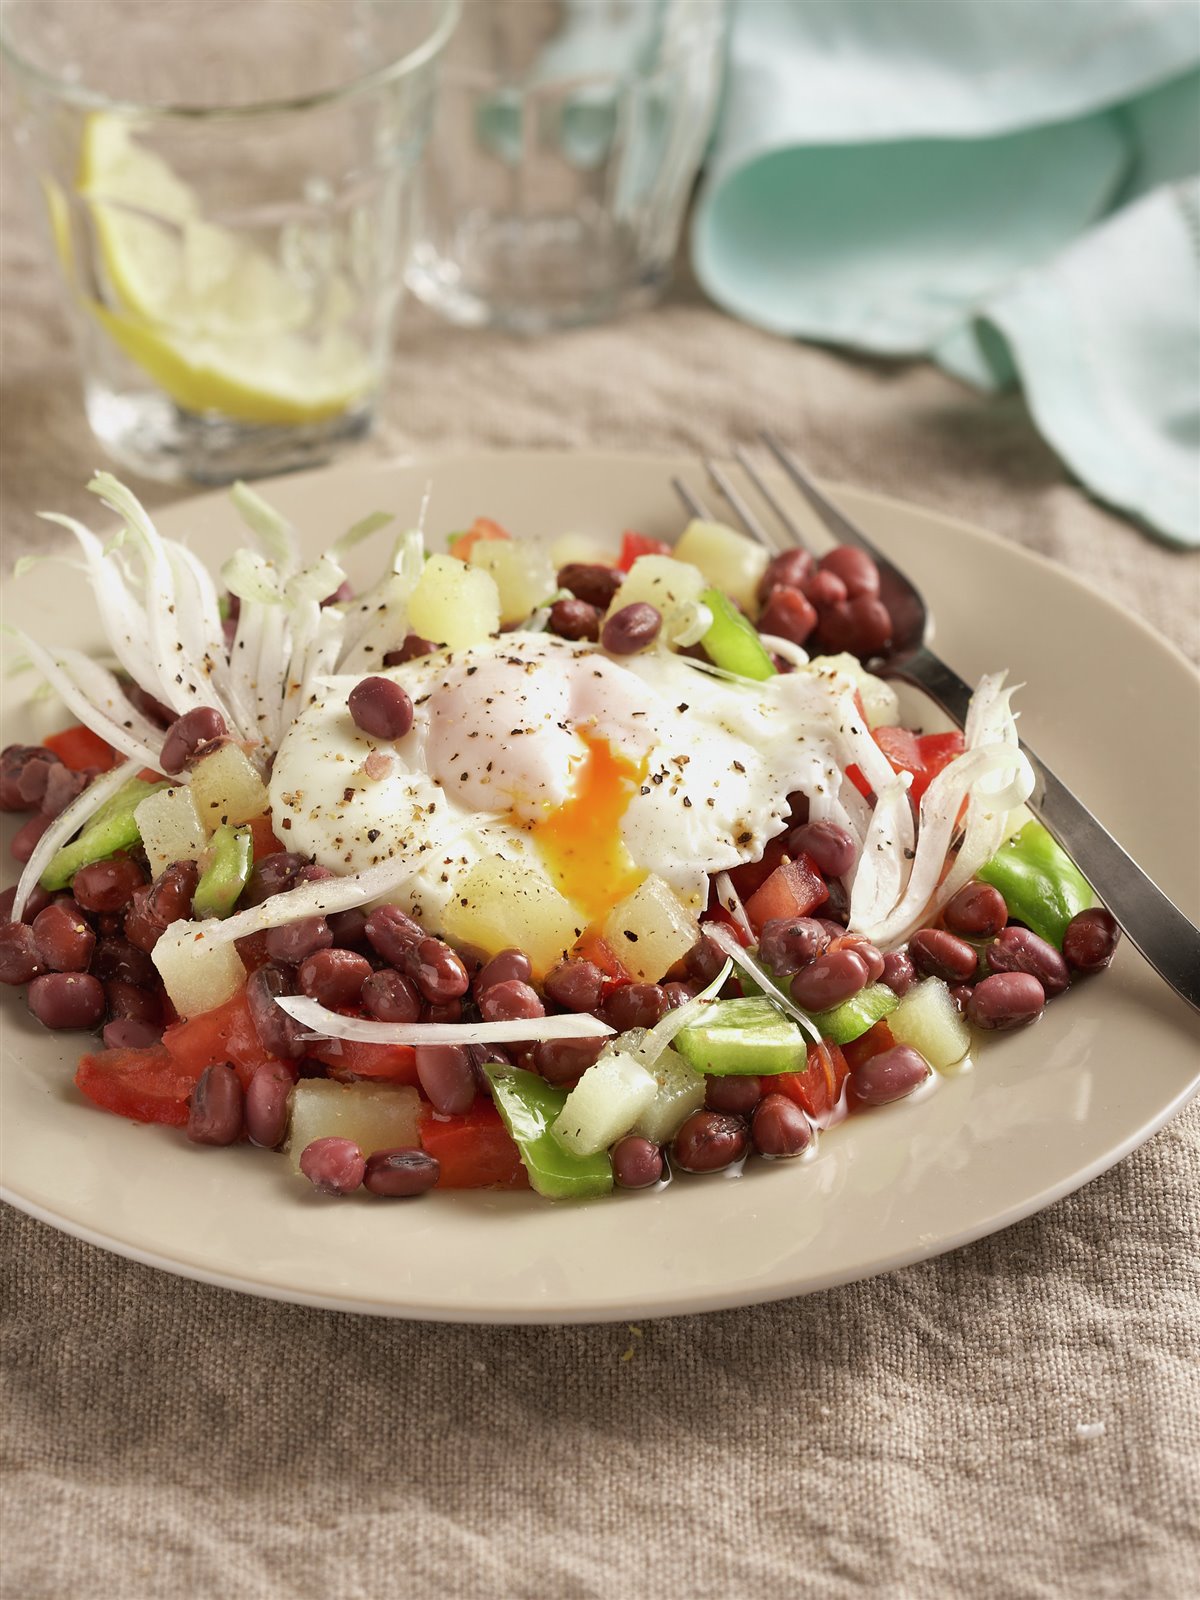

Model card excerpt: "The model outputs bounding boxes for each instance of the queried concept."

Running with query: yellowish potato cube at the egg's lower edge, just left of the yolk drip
[442,856,588,976]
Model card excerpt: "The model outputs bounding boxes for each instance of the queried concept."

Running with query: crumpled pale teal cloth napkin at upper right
[691,0,1200,544]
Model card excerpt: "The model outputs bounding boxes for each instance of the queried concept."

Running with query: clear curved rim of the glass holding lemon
[0,0,464,122]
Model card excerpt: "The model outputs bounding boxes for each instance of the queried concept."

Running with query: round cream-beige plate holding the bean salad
[0,453,1200,1322]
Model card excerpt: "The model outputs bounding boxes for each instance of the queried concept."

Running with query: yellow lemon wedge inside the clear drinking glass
[77,112,376,426]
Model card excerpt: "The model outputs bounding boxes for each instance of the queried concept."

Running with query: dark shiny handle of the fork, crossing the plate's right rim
[886,650,1200,1011]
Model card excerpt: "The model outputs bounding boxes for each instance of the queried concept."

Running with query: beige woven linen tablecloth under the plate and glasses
[0,152,1200,1600]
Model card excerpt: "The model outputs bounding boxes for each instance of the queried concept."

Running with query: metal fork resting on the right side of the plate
[674,434,1200,1011]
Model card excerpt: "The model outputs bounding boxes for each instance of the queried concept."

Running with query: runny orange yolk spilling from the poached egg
[533,730,646,926]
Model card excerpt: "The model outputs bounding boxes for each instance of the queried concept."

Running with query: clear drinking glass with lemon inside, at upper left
[0,0,459,483]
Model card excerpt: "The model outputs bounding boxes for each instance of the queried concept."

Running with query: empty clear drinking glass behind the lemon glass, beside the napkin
[408,0,728,333]
